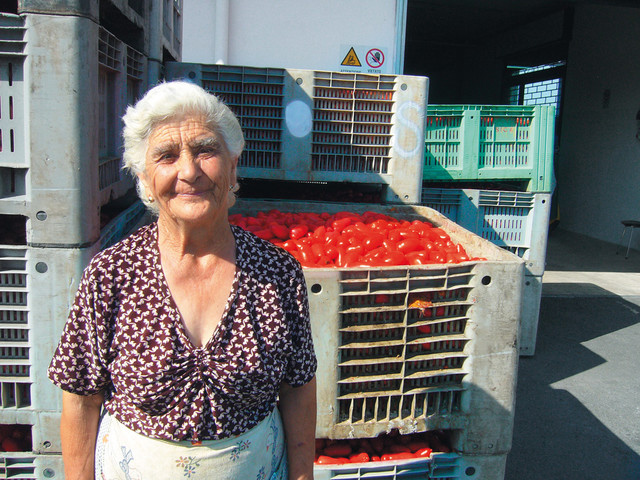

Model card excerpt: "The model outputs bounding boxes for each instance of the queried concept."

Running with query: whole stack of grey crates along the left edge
[0,0,182,479]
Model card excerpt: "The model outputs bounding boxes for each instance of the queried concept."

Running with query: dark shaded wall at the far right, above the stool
[556,6,640,248]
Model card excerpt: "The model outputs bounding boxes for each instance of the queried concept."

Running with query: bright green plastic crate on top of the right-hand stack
[423,105,555,192]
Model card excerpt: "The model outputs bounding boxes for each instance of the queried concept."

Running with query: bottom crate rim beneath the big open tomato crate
[313,453,507,480]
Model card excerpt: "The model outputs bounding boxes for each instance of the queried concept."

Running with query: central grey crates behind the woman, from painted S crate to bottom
[166,63,523,480]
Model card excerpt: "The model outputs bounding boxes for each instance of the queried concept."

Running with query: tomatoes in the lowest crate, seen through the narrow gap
[315,430,451,465]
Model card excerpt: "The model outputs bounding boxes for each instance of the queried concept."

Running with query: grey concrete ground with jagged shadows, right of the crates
[505,229,640,480]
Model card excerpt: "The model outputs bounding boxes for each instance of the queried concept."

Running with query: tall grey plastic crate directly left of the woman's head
[0,13,147,248]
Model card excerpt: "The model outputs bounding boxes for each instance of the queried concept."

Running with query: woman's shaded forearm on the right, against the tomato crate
[280,377,316,480]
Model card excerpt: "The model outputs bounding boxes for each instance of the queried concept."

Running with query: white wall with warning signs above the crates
[182,0,406,73]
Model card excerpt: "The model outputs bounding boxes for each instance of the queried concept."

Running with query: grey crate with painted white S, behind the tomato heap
[166,62,428,203]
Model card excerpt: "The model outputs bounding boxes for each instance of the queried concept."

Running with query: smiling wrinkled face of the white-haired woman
[139,116,237,229]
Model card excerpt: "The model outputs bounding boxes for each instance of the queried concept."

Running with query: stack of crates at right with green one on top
[422,105,555,355]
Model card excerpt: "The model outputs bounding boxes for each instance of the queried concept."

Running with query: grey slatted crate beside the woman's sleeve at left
[0,202,146,454]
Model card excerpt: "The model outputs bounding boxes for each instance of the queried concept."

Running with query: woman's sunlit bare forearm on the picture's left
[60,391,104,480]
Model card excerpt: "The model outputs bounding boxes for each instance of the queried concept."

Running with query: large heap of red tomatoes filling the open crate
[229,210,481,268]
